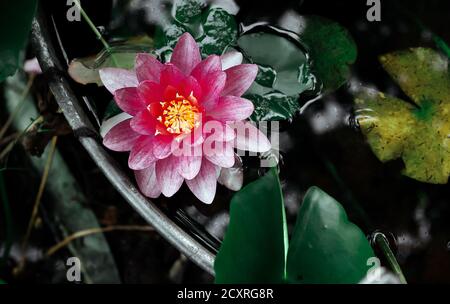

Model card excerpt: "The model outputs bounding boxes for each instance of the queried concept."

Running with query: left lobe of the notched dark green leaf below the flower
[214,169,287,283]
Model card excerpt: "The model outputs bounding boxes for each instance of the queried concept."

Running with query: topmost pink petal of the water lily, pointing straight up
[170,33,202,75]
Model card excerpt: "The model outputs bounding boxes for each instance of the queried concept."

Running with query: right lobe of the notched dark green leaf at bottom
[286,187,375,284]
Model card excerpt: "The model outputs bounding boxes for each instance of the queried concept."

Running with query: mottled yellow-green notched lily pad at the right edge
[355,48,450,184]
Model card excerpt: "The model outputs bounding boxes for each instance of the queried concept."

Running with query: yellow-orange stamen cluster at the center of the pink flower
[158,93,199,134]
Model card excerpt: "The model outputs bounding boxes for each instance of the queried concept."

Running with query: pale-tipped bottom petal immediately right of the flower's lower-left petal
[156,156,184,197]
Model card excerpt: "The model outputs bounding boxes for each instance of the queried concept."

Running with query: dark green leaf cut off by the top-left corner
[0,0,37,82]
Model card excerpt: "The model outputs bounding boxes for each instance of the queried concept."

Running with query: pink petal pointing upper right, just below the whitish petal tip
[222,64,258,96]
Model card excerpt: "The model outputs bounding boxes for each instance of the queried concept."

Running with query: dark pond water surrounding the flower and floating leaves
[4,0,450,283]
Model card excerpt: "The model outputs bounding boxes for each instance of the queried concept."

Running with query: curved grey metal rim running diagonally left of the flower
[31,7,215,275]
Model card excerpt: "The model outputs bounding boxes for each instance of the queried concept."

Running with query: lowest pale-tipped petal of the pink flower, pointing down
[186,159,219,204]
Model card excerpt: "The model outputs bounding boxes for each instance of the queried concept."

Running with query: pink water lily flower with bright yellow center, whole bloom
[100,33,270,204]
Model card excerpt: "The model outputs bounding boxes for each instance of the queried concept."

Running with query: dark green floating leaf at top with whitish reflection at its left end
[280,14,358,92]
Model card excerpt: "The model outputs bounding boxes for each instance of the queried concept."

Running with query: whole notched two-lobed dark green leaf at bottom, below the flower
[214,168,375,284]
